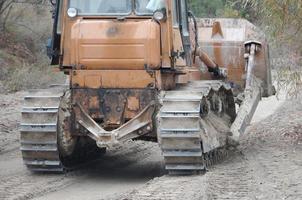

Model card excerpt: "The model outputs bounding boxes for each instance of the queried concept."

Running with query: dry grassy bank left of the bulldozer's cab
[0,5,64,92]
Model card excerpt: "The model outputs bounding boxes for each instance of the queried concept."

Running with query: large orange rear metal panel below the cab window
[70,19,161,70]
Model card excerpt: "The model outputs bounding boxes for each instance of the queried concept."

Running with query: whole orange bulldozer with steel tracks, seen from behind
[20,0,274,174]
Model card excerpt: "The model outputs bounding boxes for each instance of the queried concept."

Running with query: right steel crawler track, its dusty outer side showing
[159,81,235,174]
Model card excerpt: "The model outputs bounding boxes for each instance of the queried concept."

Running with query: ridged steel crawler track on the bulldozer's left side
[20,89,64,172]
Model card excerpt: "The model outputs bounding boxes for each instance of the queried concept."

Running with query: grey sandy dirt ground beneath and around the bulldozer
[0,92,302,200]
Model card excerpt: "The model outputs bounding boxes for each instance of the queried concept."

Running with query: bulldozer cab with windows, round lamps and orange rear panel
[48,0,193,72]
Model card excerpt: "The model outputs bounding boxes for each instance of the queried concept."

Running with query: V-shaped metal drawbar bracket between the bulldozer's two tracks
[75,102,155,148]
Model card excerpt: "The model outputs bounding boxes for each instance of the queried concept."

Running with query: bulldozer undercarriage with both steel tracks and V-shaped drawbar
[21,81,235,173]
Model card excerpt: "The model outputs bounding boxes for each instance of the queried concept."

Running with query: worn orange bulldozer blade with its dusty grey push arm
[197,18,274,144]
